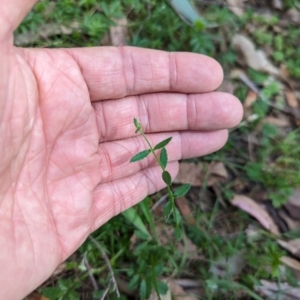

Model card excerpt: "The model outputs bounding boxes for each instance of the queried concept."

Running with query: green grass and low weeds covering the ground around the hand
[20,0,300,300]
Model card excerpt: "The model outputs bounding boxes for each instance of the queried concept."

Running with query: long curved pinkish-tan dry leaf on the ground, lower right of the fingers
[231,195,279,235]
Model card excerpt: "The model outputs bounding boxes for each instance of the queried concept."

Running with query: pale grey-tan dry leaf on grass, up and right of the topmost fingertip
[232,34,280,76]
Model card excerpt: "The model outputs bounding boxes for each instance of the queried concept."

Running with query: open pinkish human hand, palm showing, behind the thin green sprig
[0,0,242,300]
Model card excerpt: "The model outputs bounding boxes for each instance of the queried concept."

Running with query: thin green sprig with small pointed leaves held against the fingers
[130,118,191,240]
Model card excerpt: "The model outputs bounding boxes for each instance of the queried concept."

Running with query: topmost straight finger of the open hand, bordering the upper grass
[66,47,223,101]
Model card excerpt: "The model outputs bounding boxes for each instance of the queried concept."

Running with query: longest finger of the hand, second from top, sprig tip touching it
[93,92,242,142]
